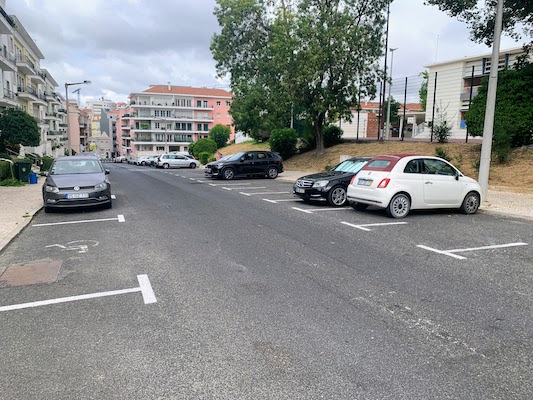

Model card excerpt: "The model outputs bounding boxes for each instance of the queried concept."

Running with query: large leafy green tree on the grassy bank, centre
[211,0,388,153]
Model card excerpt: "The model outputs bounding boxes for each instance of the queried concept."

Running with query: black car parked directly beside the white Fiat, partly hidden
[293,157,372,207]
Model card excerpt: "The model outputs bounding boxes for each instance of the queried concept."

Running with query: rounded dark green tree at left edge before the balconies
[0,108,41,153]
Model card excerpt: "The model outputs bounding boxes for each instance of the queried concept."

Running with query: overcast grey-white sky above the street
[6,0,522,103]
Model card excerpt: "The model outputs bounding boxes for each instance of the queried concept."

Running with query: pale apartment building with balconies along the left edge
[0,0,66,154]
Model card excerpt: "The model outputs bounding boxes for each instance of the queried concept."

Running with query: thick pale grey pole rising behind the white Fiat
[478,0,503,201]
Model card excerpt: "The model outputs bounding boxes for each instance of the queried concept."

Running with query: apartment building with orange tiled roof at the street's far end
[128,84,235,156]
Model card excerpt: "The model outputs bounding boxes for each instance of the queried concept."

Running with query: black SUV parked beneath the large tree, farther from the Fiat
[204,151,283,179]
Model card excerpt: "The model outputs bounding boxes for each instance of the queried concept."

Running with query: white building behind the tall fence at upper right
[425,48,524,139]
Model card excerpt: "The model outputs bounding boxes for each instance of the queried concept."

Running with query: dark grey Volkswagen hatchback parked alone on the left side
[43,156,112,212]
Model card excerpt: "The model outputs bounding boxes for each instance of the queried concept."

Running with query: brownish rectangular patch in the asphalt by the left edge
[0,260,63,288]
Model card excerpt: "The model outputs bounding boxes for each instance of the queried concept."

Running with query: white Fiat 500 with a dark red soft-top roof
[347,154,481,218]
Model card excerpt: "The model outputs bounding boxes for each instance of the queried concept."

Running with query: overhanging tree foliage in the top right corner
[426,0,533,45]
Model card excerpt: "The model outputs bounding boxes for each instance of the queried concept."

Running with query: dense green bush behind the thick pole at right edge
[465,64,533,162]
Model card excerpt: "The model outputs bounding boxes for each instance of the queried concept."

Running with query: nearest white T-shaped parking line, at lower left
[0,275,157,311]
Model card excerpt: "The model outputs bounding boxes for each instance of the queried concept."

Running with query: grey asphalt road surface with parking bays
[0,164,533,400]
